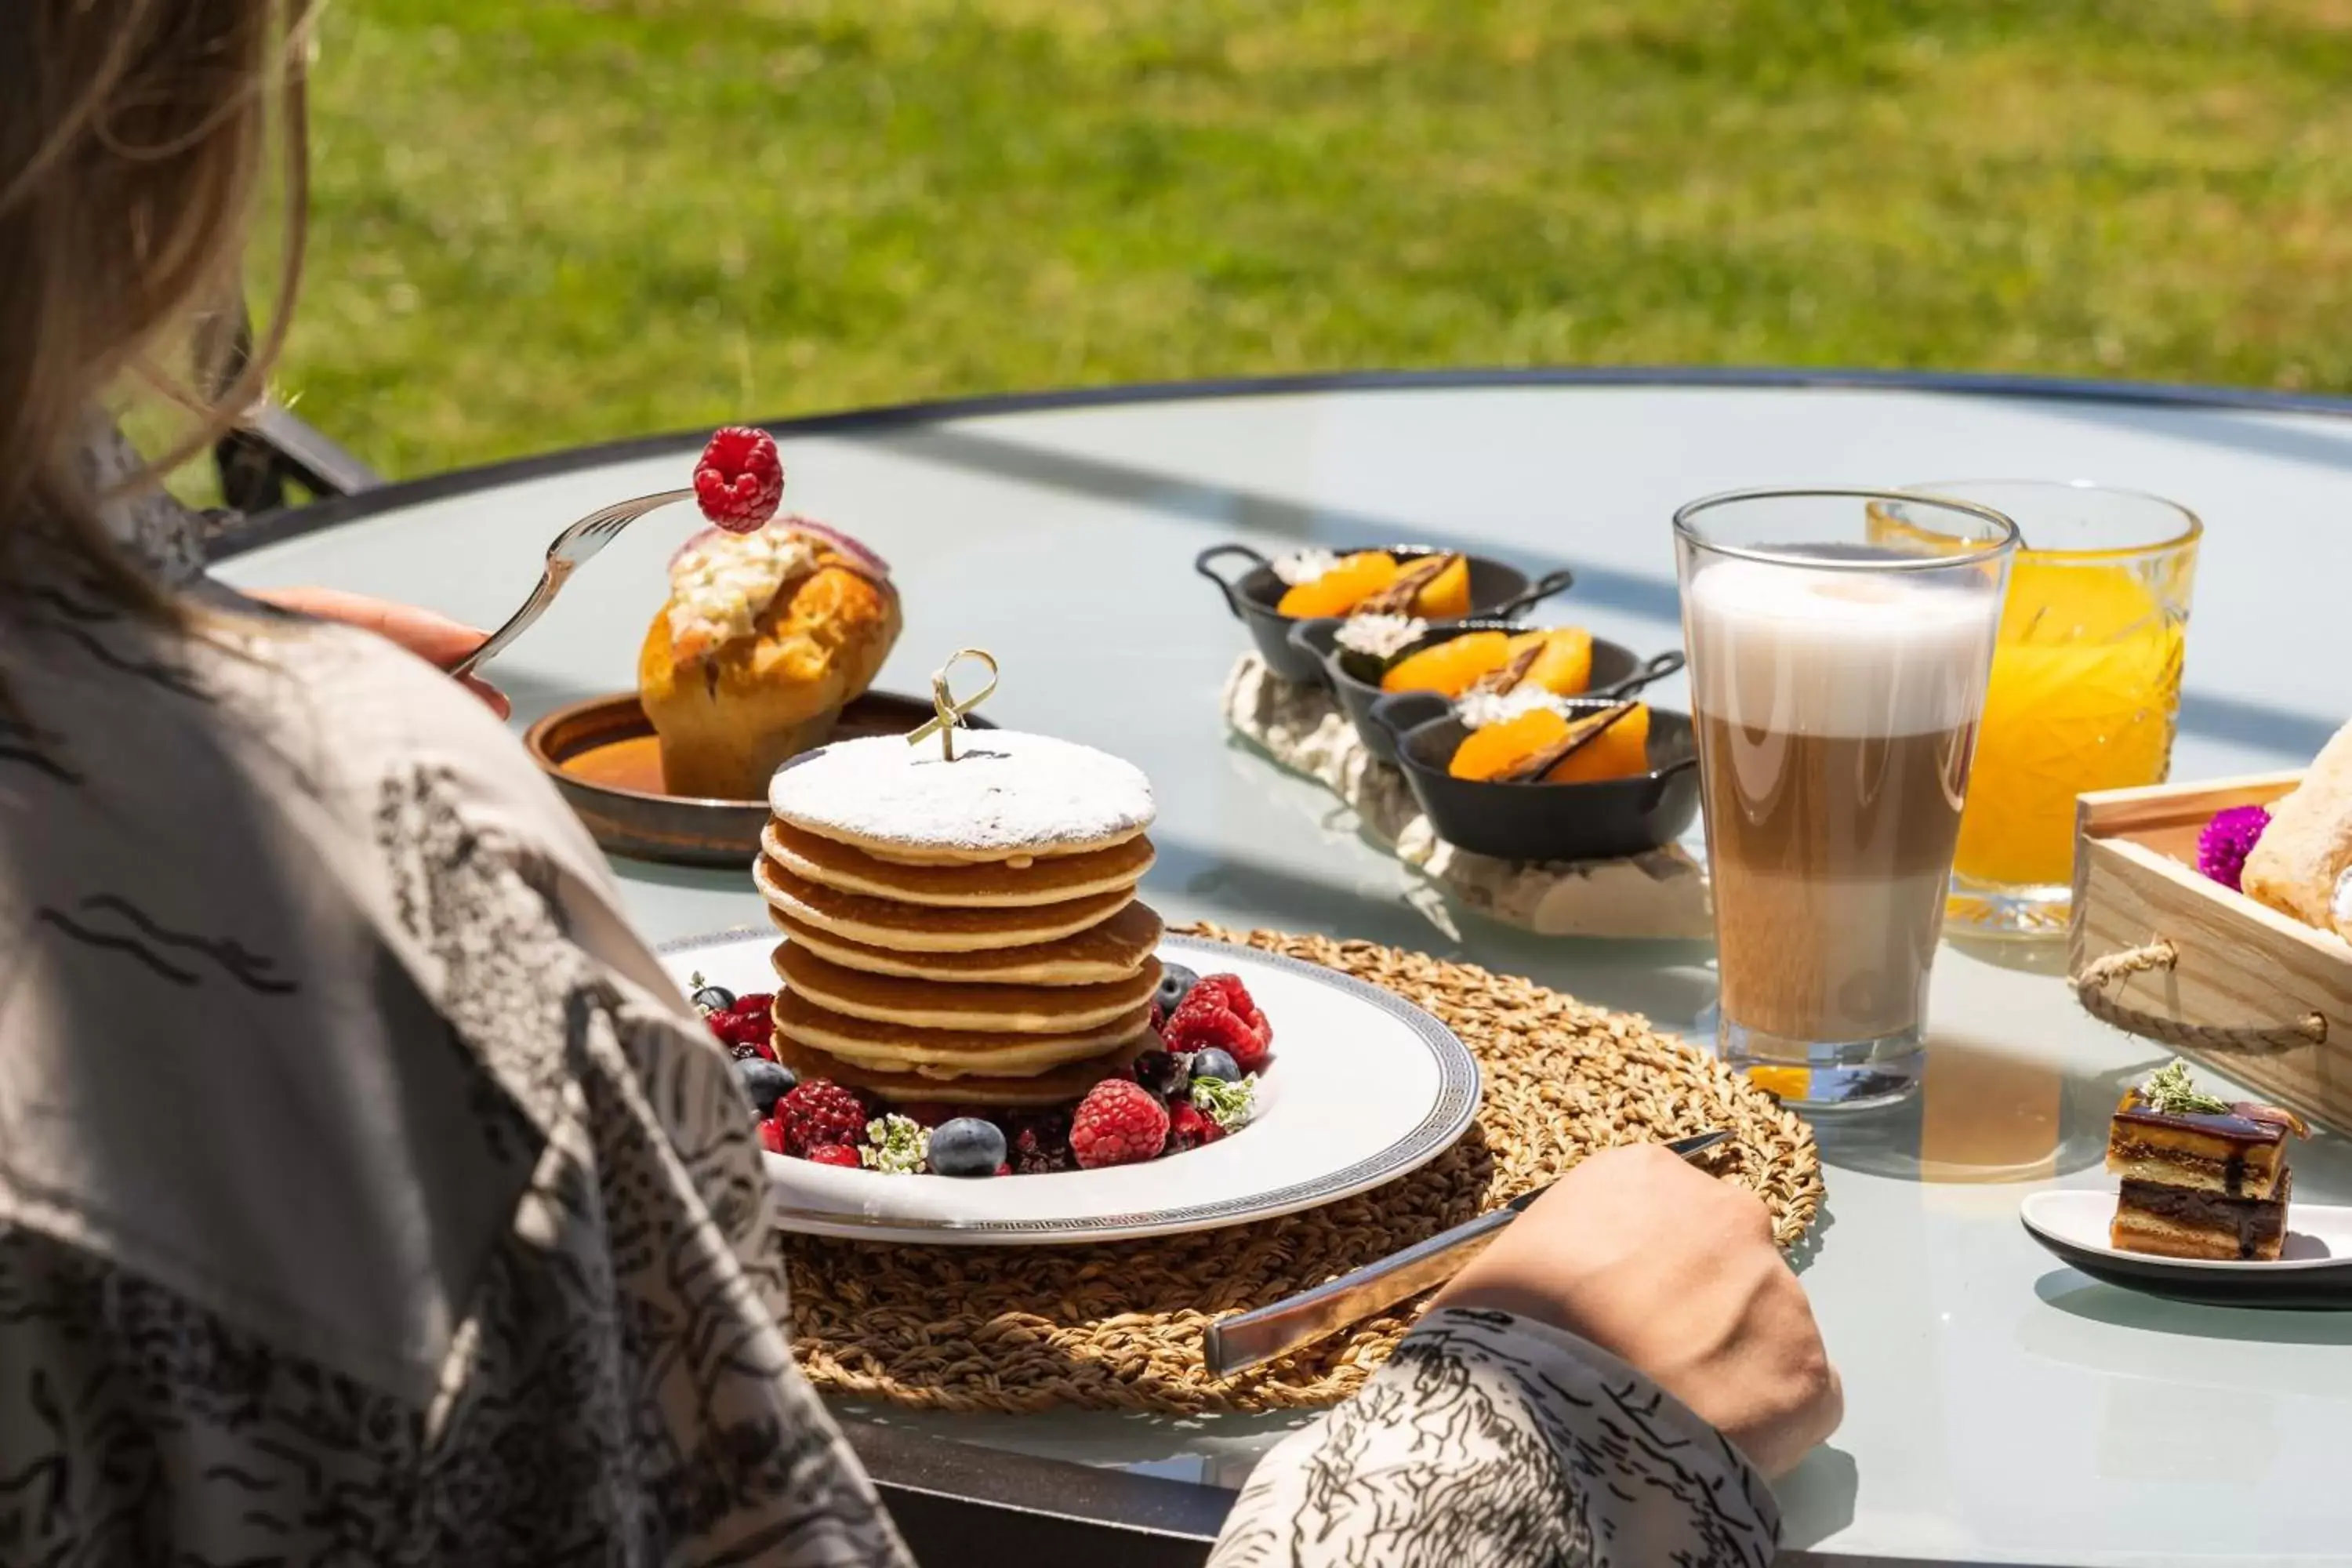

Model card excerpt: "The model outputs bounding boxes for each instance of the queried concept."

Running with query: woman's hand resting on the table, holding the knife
[1437,1142,1846,1476]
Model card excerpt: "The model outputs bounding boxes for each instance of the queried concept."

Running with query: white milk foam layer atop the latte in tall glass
[1682,560,1999,736]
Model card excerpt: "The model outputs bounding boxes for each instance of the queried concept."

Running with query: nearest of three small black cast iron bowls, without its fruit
[1371,691,1698,860]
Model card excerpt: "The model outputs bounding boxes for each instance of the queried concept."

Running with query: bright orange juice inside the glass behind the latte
[1952,548,2185,886]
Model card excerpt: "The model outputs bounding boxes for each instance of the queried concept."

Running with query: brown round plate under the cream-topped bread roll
[522,691,995,869]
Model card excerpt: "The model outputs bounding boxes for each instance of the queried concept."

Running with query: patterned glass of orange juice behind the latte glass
[1872,480,2204,935]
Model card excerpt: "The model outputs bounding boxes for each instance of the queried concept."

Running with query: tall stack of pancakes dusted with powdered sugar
[753,731,1160,1107]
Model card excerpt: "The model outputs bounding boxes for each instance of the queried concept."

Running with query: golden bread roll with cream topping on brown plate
[637,520,898,799]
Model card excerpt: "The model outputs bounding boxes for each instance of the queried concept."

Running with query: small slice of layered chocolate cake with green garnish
[2107,1062,2310,1260]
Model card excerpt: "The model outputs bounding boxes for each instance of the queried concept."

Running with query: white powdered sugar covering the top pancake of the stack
[767,729,1157,858]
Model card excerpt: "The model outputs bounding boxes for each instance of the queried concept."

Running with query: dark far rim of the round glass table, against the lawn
[207,365,2352,562]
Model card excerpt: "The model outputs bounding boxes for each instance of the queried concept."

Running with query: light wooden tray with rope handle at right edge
[2067,774,2352,1128]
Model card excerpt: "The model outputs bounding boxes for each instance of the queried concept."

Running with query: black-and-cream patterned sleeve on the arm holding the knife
[1211,1309,1780,1568]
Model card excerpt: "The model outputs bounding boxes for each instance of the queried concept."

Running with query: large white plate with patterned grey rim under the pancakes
[661,931,1479,1246]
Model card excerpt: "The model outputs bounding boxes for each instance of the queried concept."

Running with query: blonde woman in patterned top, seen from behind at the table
[0,0,1837,1563]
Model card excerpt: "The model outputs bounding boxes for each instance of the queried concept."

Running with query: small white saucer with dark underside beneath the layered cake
[2018,1187,2352,1309]
